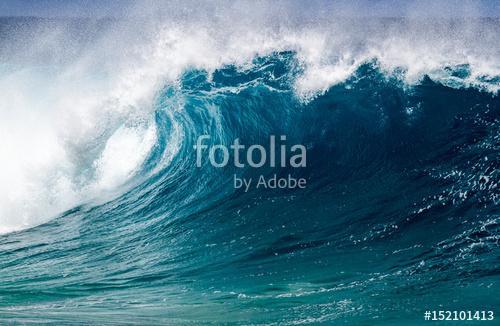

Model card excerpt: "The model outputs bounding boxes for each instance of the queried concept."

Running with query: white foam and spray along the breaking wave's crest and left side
[0,20,500,232]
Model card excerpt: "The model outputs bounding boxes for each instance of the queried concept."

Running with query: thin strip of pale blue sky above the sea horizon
[0,0,500,18]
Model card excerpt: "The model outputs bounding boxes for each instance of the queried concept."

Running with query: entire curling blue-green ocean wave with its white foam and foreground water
[0,14,500,324]
